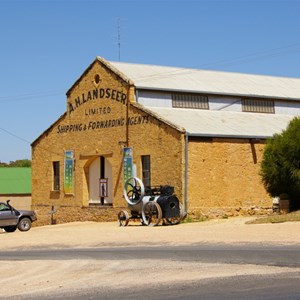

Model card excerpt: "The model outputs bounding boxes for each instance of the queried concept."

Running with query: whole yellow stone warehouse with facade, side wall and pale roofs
[32,57,300,222]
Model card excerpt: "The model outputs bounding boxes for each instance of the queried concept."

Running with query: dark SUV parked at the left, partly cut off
[0,200,37,232]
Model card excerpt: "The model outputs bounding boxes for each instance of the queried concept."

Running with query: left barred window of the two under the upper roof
[172,93,209,109]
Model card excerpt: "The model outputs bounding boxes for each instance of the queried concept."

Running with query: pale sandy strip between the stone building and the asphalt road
[0,217,300,250]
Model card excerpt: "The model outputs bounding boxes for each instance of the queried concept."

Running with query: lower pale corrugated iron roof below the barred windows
[148,107,294,138]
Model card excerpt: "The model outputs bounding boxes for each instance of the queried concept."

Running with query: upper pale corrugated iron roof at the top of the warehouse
[110,62,300,100]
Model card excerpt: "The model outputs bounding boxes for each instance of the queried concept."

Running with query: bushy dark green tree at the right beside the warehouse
[261,117,300,209]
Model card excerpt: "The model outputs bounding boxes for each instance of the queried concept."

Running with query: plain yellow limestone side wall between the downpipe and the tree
[188,139,272,215]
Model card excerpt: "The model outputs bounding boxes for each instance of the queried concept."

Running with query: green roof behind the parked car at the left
[0,167,31,195]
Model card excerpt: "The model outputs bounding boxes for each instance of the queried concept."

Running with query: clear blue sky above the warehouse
[0,0,300,162]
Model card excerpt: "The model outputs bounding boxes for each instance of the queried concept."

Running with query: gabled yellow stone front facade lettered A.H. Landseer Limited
[32,58,184,221]
